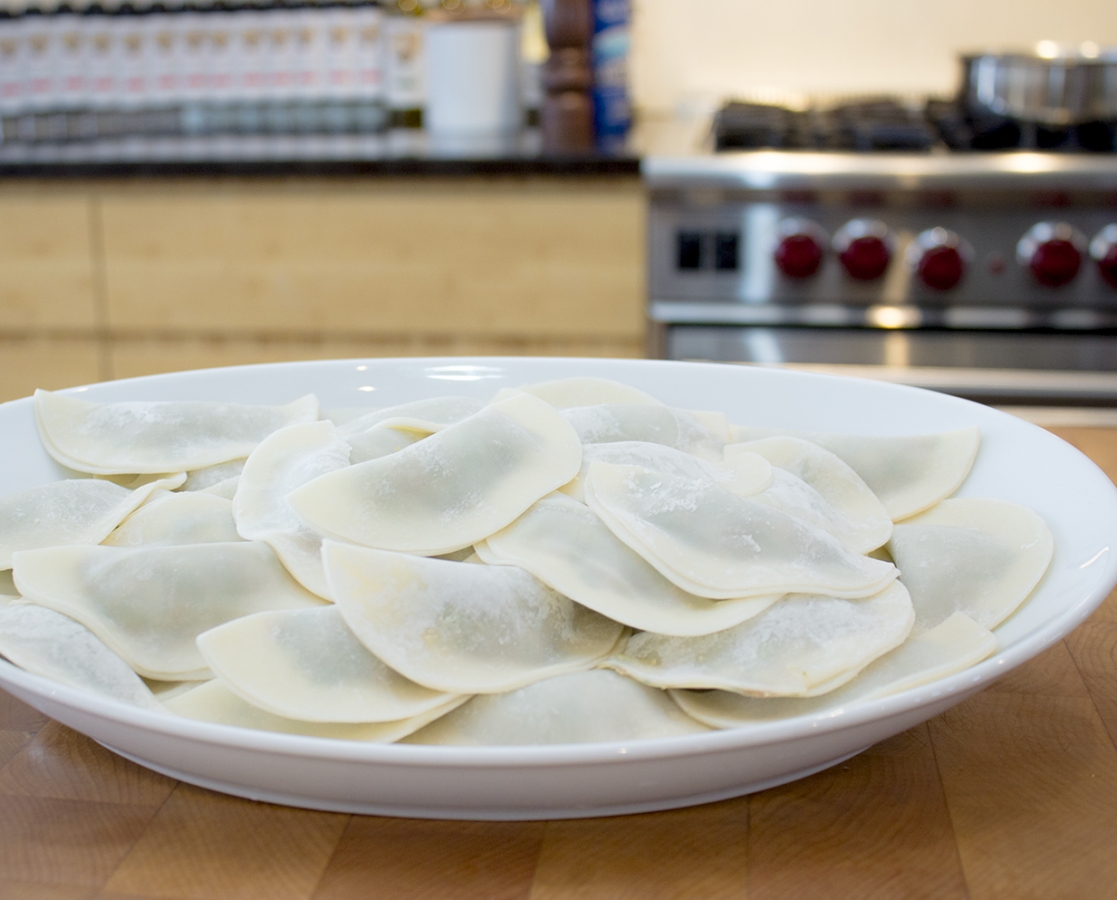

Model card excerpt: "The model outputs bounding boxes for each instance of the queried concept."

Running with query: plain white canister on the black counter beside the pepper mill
[423,19,523,135]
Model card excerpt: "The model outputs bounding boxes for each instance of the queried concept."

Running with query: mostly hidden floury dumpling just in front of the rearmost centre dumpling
[562,403,729,461]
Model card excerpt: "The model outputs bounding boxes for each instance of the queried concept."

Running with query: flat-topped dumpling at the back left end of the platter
[35,391,318,475]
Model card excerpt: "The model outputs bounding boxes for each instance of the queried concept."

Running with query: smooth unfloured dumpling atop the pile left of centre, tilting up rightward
[287,394,582,556]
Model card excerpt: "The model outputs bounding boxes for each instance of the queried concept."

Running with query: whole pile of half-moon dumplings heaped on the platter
[0,377,1052,745]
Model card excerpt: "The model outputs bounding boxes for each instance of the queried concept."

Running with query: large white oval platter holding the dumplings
[0,357,1117,820]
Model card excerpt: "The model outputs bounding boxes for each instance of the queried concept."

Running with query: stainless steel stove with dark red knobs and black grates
[643,94,1117,402]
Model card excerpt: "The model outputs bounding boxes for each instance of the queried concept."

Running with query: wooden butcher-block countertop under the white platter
[0,428,1117,900]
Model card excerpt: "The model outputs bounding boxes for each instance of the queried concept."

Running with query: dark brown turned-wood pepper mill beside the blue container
[540,0,594,153]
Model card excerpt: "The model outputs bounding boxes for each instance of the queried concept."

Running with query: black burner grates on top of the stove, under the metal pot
[713,97,1117,153]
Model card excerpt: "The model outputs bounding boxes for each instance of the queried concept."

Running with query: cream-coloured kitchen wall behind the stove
[632,0,1117,112]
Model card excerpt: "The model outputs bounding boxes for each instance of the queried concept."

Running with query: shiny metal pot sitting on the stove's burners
[962,41,1117,127]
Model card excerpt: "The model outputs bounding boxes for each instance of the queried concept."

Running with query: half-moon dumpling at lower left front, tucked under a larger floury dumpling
[198,607,452,722]
